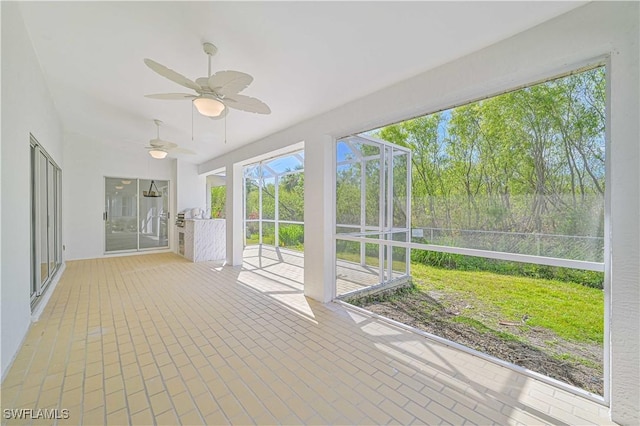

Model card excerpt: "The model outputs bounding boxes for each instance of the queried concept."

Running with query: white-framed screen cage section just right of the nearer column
[335,136,411,296]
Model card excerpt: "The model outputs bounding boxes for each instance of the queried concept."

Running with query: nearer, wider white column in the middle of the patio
[304,135,335,303]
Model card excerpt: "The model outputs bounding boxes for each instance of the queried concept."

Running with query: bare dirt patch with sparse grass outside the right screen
[347,290,603,395]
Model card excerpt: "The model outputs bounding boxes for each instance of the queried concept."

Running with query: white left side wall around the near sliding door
[0,2,65,377]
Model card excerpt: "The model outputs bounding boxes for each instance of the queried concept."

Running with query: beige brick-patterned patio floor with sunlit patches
[1,248,610,425]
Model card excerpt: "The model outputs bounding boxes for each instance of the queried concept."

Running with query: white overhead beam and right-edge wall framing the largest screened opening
[199,2,640,424]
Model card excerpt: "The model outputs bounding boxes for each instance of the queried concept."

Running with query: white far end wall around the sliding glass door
[62,134,176,259]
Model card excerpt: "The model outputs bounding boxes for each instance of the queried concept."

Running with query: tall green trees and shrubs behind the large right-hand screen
[370,67,606,262]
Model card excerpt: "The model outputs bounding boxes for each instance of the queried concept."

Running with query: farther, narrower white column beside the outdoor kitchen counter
[226,164,244,266]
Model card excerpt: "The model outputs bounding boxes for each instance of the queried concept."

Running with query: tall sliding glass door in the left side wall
[30,136,62,305]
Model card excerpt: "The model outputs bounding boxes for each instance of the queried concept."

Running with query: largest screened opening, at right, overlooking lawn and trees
[336,64,611,395]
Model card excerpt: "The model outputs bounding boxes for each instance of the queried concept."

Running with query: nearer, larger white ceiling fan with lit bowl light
[144,42,271,119]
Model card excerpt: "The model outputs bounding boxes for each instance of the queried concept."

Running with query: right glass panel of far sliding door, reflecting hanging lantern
[138,179,169,250]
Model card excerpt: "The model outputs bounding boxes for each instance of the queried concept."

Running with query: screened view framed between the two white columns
[244,151,304,251]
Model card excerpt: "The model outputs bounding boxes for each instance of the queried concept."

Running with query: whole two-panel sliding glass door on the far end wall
[104,177,169,252]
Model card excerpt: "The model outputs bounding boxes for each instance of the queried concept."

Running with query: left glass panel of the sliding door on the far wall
[105,178,138,252]
